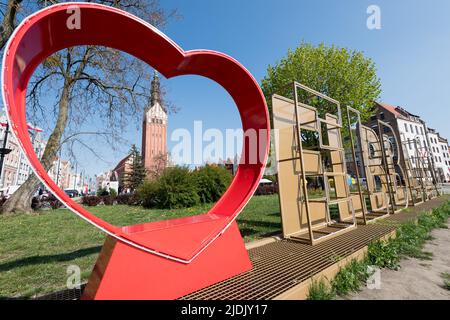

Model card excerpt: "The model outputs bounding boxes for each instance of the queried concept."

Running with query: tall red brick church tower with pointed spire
[141,71,167,172]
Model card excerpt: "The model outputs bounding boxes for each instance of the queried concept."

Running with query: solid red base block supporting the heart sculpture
[82,219,252,300]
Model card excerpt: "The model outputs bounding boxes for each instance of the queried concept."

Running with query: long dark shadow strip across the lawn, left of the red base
[0,246,102,272]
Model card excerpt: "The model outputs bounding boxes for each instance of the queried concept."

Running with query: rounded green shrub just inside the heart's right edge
[193,165,232,203]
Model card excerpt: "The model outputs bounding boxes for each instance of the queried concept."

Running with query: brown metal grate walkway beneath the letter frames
[182,224,395,300]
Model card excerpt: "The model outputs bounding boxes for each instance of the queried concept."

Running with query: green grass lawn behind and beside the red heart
[0,195,281,298]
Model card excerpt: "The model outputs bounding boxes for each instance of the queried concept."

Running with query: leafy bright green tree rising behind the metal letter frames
[262,42,381,121]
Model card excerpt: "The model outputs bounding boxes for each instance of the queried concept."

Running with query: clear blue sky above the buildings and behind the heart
[7,0,450,179]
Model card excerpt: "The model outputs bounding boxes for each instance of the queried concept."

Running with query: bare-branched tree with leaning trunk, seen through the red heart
[2,0,178,213]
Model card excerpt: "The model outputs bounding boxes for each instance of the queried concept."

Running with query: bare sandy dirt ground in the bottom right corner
[347,223,450,300]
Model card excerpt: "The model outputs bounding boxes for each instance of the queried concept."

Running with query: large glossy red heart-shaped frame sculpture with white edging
[2,3,269,263]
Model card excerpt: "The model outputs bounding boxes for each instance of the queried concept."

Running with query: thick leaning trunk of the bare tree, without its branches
[1,78,73,214]
